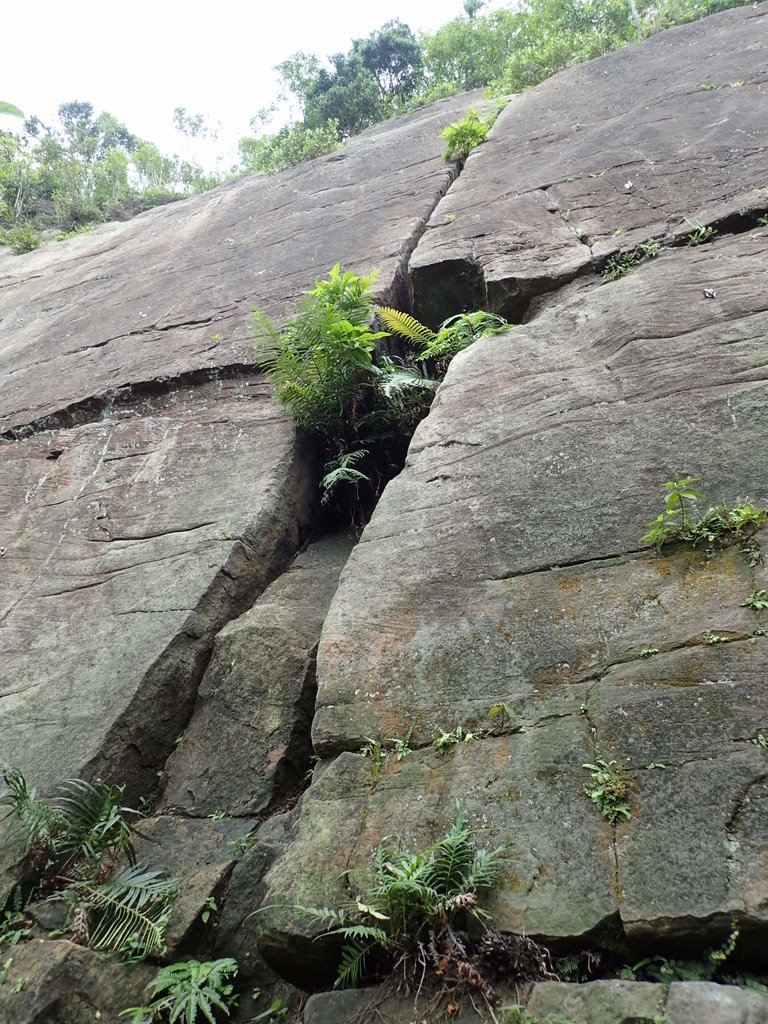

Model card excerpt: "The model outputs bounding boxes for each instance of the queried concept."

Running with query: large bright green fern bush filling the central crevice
[250,264,438,525]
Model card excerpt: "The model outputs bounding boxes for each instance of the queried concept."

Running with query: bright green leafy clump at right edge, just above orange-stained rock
[640,476,768,552]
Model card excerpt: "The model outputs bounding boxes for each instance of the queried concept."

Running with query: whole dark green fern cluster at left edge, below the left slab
[0,765,176,959]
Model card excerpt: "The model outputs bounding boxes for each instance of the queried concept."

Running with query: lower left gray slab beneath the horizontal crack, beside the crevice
[0,378,314,801]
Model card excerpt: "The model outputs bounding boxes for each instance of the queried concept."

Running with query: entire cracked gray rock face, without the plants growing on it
[0,4,768,1024]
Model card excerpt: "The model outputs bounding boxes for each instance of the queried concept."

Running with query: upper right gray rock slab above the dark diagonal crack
[411,4,768,322]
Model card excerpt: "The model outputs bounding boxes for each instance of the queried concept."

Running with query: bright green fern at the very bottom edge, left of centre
[120,957,237,1024]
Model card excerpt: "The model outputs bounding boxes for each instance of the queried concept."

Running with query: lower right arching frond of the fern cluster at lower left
[61,864,177,959]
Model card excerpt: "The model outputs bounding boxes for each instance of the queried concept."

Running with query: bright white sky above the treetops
[6,0,514,166]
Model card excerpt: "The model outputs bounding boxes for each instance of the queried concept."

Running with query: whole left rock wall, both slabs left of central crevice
[0,97,476,803]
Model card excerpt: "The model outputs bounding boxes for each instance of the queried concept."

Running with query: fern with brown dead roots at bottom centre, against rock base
[298,804,504,997]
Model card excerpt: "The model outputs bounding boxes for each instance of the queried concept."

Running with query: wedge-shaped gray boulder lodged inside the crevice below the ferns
[164,536,354,815]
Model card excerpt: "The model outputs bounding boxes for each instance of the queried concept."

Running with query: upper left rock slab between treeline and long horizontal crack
[0,93,481,433]
